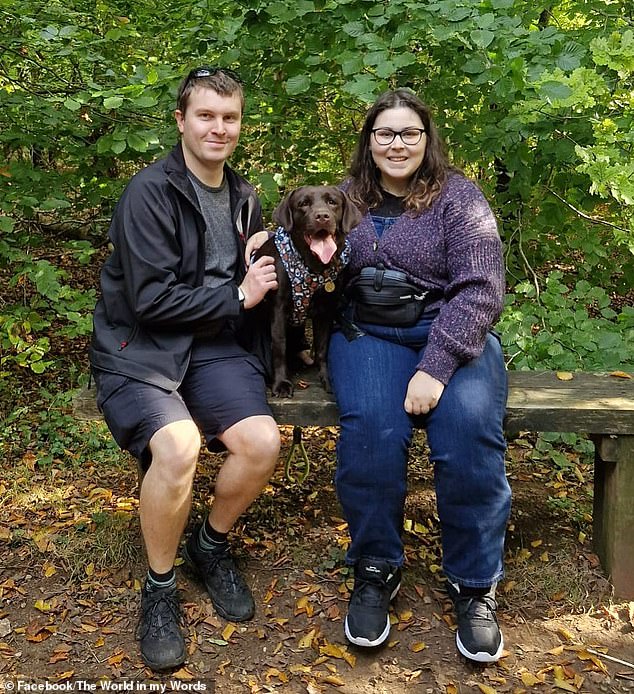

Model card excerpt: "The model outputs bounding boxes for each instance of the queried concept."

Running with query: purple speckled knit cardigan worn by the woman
[346,174,505,385]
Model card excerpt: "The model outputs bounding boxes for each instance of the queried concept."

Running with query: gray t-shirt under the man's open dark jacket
[187,171,239,287]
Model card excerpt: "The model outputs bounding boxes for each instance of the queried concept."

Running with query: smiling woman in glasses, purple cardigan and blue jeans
[328,89,511,662]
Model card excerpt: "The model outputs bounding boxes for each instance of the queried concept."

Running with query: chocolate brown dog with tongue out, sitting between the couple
[256,186,361,397]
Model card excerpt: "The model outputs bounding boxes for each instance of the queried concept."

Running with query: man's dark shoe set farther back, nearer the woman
[183,525,255,622]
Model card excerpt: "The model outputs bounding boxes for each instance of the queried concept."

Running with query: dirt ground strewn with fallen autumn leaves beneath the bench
[0,428,634,694]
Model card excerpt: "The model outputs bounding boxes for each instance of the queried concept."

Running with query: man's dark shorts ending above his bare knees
[93,338,272,465]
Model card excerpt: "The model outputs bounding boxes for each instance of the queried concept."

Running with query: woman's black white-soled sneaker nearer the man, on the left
[344,558,401,648]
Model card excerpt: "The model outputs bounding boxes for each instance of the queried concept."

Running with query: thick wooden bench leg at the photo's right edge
[593,436,634,600]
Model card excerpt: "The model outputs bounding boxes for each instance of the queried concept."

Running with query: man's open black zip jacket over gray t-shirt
[90,144,262,390]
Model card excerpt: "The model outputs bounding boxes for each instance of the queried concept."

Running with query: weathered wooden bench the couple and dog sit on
[75,371,634,599]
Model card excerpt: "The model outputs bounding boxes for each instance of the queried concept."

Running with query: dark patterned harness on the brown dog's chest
[273,227,350,325]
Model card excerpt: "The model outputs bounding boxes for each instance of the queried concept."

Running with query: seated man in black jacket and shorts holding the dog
[90,68,280,670]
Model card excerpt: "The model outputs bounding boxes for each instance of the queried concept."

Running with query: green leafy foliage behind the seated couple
[0,0,634,386]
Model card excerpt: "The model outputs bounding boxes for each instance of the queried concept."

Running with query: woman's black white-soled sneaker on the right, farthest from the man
[447,582,504,663]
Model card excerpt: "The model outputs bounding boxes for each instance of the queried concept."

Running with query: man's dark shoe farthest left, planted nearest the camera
[136,584,185,670]
